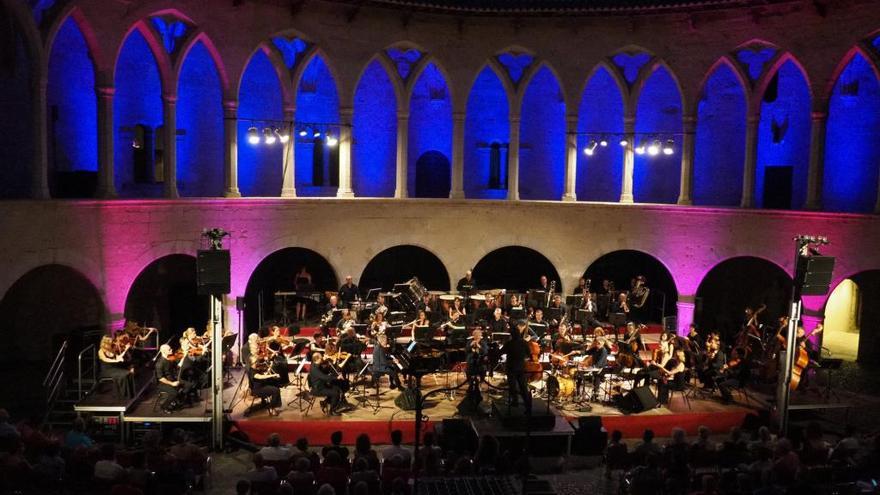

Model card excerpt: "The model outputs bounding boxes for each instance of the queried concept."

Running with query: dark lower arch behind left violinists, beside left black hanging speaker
[125,254,210,341]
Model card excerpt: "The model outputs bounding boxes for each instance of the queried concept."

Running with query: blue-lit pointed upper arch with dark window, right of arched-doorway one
[463,61,512,199]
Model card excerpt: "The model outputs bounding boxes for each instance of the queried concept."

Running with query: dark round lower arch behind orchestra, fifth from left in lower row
[473,246,562,293]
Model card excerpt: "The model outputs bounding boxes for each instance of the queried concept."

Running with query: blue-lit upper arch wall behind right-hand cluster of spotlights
[633,66,681,203]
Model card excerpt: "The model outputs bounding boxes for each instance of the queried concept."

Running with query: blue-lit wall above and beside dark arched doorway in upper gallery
[407,63,452,197]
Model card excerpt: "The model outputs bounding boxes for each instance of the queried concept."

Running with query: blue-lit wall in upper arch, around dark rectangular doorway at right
[755,61,810,209]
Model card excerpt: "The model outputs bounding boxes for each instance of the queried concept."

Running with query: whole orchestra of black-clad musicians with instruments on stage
[97,268,822,416]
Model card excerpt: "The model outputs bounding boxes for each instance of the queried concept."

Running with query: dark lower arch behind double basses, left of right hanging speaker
[694,256,792,342]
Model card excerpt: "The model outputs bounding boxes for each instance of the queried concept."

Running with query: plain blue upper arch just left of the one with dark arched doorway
[351,60,397,197]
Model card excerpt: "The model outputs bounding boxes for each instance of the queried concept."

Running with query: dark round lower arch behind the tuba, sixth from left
[583,249,678,322]
